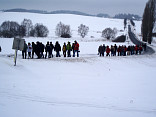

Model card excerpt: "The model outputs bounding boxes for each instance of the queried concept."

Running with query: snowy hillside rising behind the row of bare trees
[0,12,141,38]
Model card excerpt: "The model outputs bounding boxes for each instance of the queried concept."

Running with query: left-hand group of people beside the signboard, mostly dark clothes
[22,41,80,59]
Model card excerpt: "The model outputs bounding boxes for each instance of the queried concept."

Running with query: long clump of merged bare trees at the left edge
[0,19,49,38]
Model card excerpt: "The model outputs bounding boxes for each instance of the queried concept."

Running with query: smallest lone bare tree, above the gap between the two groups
[78,24,89,38]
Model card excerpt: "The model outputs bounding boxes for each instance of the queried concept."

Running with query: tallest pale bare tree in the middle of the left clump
[21,19,33,37]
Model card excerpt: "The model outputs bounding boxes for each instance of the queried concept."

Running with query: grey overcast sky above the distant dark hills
[0,0,148,16]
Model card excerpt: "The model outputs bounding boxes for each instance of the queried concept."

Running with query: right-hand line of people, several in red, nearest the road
[98,44,146,56]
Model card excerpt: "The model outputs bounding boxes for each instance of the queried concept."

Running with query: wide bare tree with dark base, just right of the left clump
[55,22,71,38]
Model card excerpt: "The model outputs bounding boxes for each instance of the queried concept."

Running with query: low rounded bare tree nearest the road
[102,28,115,40]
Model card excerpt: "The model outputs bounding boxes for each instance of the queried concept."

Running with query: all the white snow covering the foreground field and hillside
[0,13,156,117]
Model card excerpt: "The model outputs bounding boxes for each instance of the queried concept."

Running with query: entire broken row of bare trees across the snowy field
[0,19,117,39]
